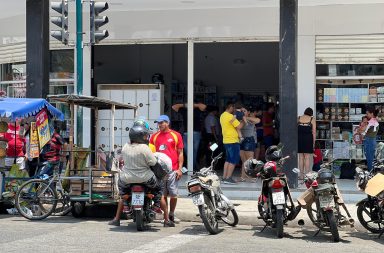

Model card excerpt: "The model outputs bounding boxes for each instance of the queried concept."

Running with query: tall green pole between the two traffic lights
[76,0,84,147]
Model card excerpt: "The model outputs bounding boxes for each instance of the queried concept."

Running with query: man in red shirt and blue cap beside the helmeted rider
[149,115,184,222]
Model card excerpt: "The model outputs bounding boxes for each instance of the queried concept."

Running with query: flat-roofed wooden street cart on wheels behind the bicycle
[48,94,138,217]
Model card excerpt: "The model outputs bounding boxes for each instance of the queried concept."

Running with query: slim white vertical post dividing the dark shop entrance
[187,40,194,175]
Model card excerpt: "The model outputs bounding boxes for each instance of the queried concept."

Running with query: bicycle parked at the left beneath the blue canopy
[15,162,72,220]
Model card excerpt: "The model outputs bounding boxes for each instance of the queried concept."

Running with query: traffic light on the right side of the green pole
[90,1,109,44]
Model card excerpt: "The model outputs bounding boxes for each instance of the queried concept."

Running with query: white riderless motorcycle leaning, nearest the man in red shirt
[187,148,239,234]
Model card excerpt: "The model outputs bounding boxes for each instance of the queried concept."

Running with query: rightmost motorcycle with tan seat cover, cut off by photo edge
[356,144,384,238]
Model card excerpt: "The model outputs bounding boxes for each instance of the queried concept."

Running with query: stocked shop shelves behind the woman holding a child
[316,80,384,160]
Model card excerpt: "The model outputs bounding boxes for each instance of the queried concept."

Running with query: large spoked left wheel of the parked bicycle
[15,179,57,220]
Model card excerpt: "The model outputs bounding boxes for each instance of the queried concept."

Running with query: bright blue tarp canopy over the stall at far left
[0,98,64,121]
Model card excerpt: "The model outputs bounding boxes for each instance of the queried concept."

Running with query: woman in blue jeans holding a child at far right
[362,107,379,171]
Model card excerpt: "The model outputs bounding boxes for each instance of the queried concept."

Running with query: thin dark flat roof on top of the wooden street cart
[48,94,138,110]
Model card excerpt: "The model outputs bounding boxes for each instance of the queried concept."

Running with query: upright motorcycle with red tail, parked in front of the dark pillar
[257,152,300,238]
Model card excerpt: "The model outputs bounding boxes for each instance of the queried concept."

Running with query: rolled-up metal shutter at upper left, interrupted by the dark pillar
[0,41,73,64]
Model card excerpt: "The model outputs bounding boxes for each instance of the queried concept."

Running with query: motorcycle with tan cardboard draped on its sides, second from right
[298,161,354,242]
